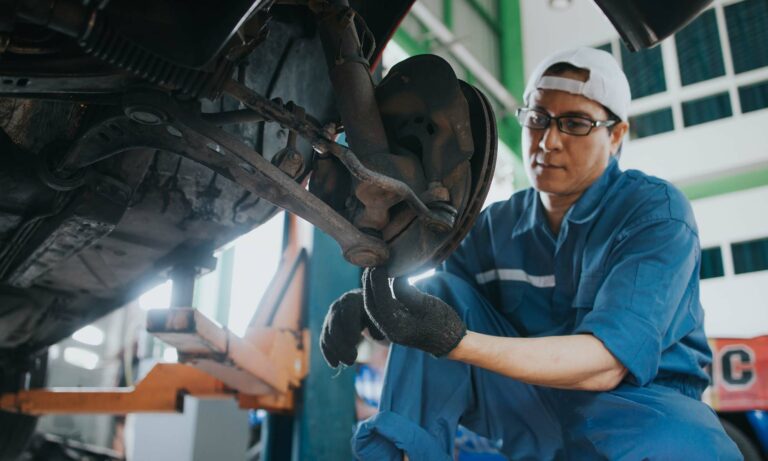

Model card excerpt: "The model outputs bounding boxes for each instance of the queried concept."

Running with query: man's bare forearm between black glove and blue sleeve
[448,331,627,391]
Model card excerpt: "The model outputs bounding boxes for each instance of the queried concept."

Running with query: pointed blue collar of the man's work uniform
[512,157,621,237]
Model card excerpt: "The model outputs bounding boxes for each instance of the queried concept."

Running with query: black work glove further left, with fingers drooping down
[320,288,384,368]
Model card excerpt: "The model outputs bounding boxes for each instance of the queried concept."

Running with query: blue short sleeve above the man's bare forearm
[574,218,700,385]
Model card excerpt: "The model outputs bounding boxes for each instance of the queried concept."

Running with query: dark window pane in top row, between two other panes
[675,10,725,85]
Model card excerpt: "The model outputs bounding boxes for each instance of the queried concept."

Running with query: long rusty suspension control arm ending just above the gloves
[50,93,388,266]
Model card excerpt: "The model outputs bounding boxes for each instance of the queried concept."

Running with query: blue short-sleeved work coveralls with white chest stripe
[353,159,741,460]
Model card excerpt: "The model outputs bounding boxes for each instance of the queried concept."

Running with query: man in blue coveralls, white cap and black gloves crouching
[321,48,741,461]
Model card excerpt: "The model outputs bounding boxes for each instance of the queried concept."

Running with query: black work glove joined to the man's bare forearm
[363,267,467,357]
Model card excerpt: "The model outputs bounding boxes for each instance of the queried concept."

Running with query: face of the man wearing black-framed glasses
[523,73,626,197]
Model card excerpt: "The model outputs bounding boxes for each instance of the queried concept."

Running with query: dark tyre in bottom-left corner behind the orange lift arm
[0,354,47,461]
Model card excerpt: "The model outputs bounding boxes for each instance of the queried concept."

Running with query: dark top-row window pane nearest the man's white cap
[621,42,667,99]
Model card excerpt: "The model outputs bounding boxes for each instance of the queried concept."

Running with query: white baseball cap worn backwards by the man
[523,47,632,121]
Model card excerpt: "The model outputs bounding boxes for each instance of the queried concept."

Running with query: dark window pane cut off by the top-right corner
[725,0,768,74]
